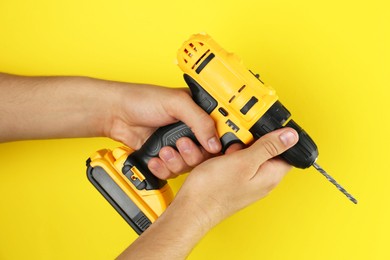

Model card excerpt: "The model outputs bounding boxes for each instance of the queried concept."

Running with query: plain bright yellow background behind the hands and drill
[0,0,390,259]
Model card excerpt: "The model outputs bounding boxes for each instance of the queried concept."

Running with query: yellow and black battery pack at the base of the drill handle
[87,147,173,234]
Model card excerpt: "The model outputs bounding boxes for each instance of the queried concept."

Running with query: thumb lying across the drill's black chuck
[247,127,299,166]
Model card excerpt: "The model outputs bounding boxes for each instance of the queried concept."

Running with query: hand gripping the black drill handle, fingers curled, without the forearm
[106,83,221,179]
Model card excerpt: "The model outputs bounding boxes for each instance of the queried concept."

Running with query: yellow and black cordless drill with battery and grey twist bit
[87,34,357,234]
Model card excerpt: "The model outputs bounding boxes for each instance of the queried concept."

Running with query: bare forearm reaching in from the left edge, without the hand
[0,74,122,142]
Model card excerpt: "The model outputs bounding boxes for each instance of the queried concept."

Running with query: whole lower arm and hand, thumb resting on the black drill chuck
[119,128,298,259]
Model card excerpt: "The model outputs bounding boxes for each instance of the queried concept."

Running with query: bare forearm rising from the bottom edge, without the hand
[118,195,213,260]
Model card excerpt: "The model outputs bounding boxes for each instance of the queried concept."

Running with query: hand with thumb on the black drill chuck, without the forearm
[177,128,298,227]
